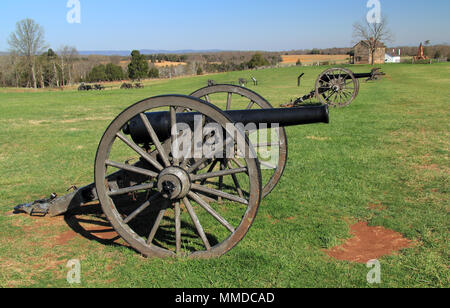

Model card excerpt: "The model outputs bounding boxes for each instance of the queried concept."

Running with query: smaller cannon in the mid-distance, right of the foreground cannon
[283,68,384,107]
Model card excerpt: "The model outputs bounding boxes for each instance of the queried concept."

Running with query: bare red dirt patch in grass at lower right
[325,222,412,263]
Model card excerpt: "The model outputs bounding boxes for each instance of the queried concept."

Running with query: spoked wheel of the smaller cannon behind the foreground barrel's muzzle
[316,68,359,107]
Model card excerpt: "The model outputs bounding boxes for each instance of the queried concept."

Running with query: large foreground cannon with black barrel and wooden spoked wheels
[15,85,329,258]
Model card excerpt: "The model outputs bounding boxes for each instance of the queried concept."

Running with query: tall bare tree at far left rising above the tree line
[8,18,46,88]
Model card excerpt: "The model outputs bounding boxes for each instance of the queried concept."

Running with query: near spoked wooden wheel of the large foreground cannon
[95,95,261,258]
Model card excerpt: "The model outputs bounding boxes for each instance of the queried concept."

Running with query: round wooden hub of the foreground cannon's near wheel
[158,167,191,200]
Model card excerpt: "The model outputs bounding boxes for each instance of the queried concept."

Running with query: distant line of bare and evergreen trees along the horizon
[0,19,450,88]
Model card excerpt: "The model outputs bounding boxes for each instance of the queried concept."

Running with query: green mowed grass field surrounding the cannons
[0,64,450,288]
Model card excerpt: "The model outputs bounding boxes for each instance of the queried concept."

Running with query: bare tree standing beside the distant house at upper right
[353,16,393,65]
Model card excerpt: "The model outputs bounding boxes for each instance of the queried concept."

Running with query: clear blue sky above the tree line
[0,0,450,51]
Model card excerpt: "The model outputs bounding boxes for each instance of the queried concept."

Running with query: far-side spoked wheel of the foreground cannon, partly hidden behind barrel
[191,85,288,197]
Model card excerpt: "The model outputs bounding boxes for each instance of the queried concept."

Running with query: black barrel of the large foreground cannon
[123,105,329,143]
